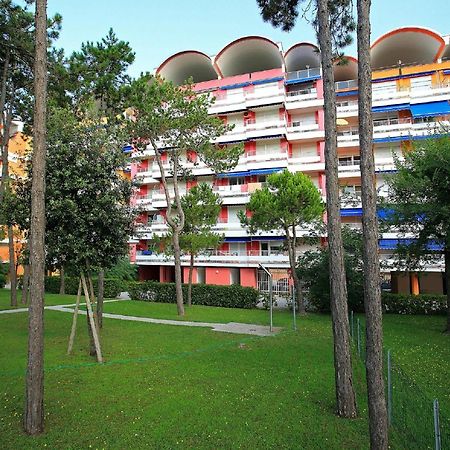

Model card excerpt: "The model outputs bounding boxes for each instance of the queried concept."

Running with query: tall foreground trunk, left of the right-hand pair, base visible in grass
[317,0,357,417]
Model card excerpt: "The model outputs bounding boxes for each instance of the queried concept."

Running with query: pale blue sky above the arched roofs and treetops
[44,0,450,76]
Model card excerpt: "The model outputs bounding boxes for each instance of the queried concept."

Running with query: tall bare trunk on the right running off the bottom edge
[357,0,388,450]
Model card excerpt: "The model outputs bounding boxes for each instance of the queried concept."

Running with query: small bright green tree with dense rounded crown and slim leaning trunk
[239,170,324,314]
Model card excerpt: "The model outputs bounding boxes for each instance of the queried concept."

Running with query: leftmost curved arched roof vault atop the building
[156,50,218,85]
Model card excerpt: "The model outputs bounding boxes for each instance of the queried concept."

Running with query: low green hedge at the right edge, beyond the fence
[382,292,447,315]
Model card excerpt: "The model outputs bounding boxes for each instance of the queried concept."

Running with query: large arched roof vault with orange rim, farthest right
[371,27,445,69]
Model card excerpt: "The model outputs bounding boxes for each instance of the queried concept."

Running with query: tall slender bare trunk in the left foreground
[24,0,47,434]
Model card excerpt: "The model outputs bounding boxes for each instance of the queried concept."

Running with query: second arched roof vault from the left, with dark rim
[214,36,283,77]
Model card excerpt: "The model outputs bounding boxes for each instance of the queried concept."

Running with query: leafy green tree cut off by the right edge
[383,130,450,333]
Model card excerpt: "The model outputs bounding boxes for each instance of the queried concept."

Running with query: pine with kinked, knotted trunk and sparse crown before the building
[130,76,243,315]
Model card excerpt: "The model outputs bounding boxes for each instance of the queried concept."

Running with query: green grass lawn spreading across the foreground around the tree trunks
[0,291,450,449]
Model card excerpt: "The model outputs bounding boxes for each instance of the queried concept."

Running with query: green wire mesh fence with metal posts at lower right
[350,312,450,450]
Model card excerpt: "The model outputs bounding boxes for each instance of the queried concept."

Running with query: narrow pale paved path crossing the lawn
[0,300,281,336]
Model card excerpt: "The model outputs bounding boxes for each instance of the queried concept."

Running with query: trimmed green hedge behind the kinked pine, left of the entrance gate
[128,281,259,309]
